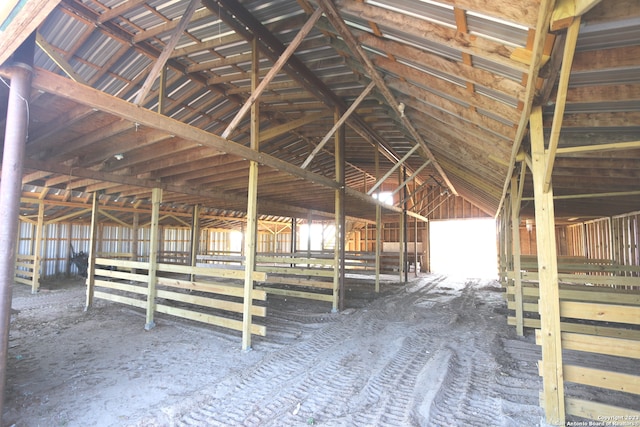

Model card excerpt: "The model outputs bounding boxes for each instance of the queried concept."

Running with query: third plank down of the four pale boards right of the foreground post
[563,365,640,394]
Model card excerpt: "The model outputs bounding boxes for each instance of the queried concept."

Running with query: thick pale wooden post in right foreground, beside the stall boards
[530,107,565,425]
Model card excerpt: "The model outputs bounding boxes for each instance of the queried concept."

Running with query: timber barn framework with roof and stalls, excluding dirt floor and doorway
[0,0,640,425]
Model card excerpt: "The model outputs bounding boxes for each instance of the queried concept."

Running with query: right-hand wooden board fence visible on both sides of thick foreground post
[505,257,640,425]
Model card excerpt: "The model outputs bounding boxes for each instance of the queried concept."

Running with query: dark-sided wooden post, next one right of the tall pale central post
[333,109,347,312]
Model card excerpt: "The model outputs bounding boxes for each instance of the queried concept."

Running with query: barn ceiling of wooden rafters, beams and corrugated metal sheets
[0,0,640,226]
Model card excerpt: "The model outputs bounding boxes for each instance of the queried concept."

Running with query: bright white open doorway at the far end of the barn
[429,218,498,279]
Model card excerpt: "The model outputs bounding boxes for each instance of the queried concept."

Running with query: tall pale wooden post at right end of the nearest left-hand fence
[242,36,260,351]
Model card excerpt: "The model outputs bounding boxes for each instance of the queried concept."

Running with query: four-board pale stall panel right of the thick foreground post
[536,300,640,425]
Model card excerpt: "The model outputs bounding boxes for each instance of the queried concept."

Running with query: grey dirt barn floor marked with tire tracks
[3,275,543,427]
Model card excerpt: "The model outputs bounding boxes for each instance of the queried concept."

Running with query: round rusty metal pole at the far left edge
[0,33,35,415]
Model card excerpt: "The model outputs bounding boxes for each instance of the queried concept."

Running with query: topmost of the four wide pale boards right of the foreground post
[560,301,640,325]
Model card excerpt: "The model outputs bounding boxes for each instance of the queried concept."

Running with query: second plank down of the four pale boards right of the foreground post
[536,329,640,359]
